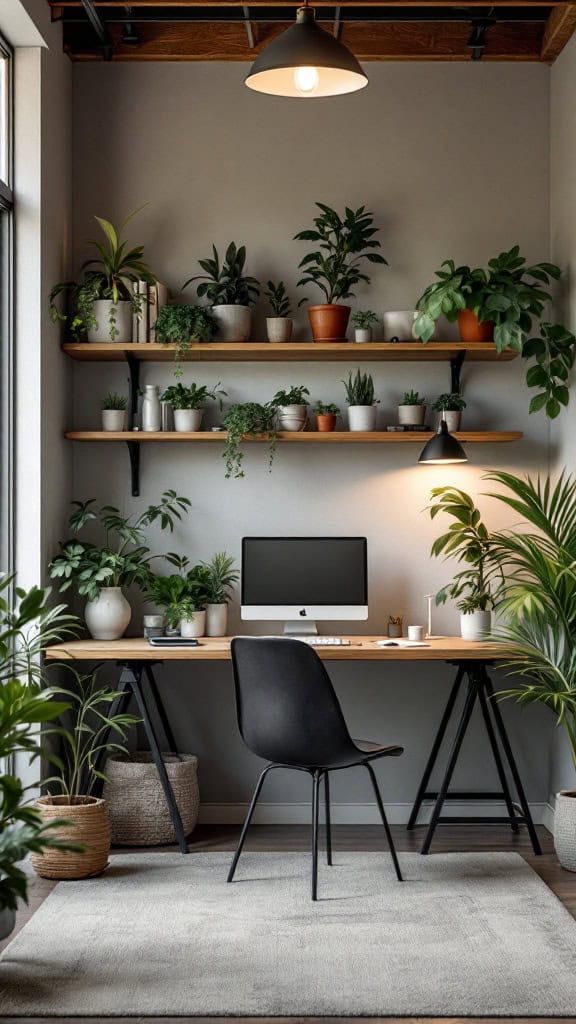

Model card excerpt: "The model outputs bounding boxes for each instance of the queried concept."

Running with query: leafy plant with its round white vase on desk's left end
[48,490,191,640]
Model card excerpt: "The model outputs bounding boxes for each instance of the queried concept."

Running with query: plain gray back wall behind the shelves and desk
[68,63,551,819]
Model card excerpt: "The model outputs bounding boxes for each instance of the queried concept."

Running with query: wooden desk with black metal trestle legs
[45,636,541,854]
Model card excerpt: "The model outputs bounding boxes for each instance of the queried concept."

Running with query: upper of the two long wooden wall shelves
[64,341,518,362]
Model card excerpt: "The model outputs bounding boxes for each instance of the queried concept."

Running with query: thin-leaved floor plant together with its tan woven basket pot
[31,666,140,879]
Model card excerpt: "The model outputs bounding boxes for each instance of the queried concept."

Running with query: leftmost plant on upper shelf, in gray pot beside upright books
[49,207,157,342]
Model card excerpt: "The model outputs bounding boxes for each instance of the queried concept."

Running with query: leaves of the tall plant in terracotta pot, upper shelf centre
[294,203,386,305]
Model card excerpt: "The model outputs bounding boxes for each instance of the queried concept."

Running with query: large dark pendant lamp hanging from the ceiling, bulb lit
[245,7,368,99]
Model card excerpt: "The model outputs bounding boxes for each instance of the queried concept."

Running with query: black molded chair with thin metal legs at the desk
[228,637,404,900]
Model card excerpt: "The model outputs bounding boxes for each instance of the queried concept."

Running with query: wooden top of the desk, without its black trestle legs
[45,636,505,662]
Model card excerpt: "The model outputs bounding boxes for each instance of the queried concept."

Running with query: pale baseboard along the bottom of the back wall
[200,800,553,831]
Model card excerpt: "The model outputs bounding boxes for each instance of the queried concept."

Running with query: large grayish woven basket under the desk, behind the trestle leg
[104,752,200,846]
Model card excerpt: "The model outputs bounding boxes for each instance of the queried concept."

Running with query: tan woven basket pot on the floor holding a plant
[31,797,110,879]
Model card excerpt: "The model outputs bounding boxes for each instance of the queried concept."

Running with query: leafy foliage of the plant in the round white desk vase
[48,490,191,601]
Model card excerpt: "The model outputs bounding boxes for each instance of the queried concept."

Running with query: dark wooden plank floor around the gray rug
[0,825,576,1024]
